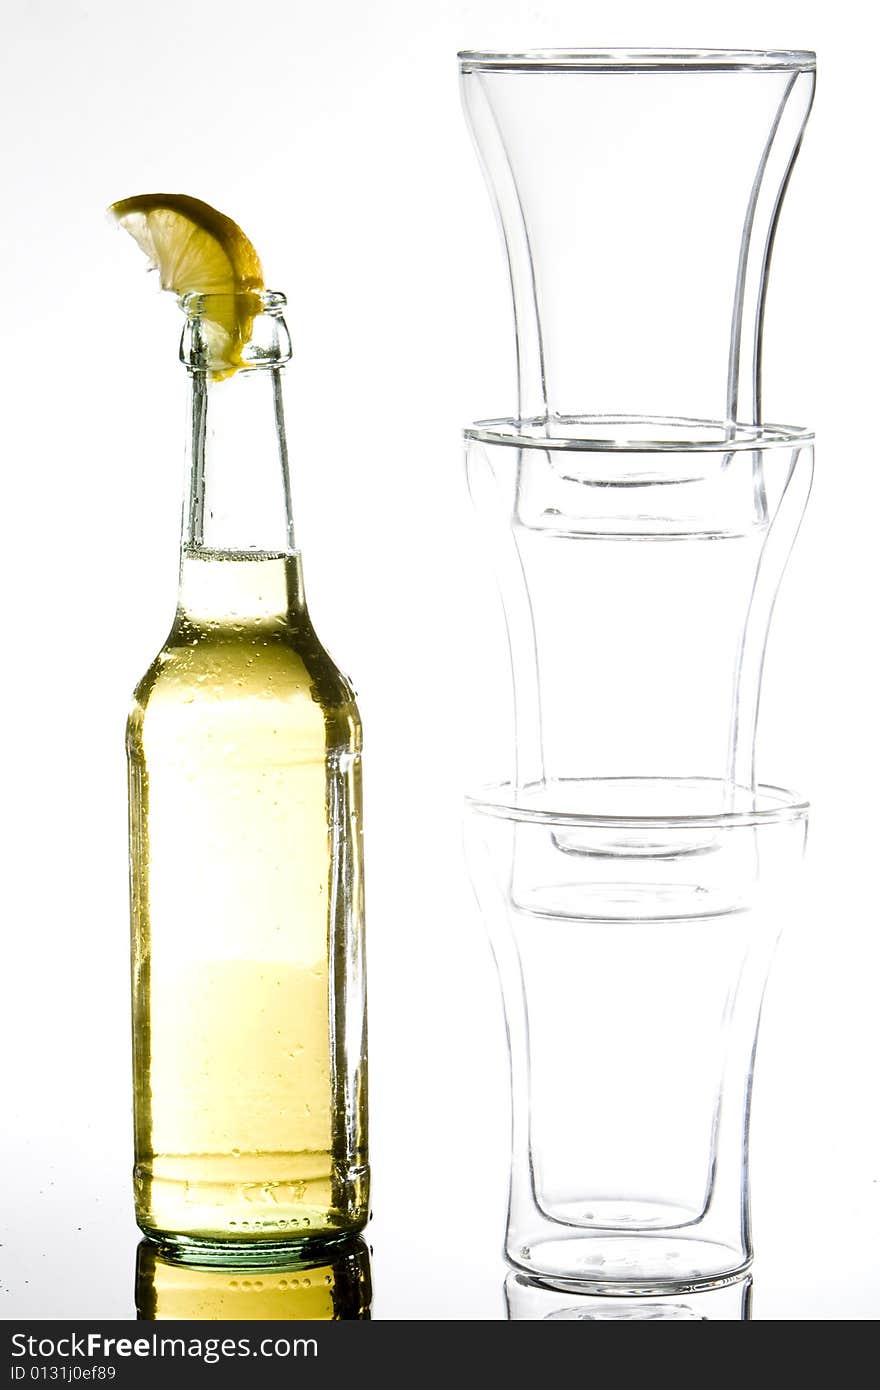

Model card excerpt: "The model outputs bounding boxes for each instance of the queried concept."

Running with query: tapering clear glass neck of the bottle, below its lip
[179,366,304,620]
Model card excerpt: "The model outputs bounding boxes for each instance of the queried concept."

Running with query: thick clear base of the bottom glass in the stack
[507,1232,752,1297]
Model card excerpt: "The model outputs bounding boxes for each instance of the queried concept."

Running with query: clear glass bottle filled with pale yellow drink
[127,290,368,1251]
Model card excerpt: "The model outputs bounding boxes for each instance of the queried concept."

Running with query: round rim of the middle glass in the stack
[464,416,816,453]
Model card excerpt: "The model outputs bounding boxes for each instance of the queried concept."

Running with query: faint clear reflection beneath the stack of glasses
[505,1272,752,1322]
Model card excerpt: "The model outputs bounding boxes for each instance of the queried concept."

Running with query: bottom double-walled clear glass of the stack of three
[466,777,808,1297]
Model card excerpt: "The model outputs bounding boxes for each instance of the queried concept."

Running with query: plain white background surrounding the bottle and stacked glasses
[0,0,880,1319]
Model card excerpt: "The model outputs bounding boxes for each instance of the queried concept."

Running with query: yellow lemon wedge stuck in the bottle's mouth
[108,193,263,378]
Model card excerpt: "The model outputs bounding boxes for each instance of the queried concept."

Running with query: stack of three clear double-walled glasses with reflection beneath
[460,50,815,1318]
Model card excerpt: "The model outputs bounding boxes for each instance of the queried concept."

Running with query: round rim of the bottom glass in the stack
[464,777,809,831]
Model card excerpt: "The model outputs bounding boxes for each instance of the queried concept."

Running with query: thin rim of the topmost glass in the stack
[459,49,816,74]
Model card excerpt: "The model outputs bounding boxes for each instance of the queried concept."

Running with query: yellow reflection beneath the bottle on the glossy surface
[135,1240,373,1322]
